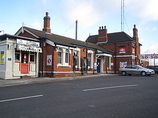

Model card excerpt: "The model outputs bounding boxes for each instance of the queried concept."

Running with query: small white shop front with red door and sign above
[0,35,42,79]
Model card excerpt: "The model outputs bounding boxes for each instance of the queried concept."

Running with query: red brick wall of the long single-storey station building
[19,32,101,77]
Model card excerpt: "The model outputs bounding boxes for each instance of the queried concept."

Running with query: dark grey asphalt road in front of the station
[0,75,158,118]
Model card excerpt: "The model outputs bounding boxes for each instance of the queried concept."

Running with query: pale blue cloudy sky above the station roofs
[0,0,158,64]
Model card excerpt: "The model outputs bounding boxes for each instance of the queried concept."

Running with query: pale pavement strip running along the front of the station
[0,74,118,87]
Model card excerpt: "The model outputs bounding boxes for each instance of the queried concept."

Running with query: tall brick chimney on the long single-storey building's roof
[43,12,51,33]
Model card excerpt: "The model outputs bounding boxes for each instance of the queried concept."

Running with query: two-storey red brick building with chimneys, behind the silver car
[86,25,142,73]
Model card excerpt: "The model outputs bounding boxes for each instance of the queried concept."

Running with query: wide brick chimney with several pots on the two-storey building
[98,26,108,43]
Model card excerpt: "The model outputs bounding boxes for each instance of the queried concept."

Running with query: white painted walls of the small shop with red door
[0,38,39,79]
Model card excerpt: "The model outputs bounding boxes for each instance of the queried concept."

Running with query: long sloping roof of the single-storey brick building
[16,27,113,54]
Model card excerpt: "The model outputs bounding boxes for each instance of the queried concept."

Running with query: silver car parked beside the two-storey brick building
[119,65,155,76]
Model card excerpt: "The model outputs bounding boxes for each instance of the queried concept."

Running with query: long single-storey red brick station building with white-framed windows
[15,12,113,77]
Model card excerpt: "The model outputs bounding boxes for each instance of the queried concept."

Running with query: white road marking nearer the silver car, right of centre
[83,84,138,92]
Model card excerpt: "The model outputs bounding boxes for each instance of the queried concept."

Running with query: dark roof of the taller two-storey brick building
[86,32,135,44]
